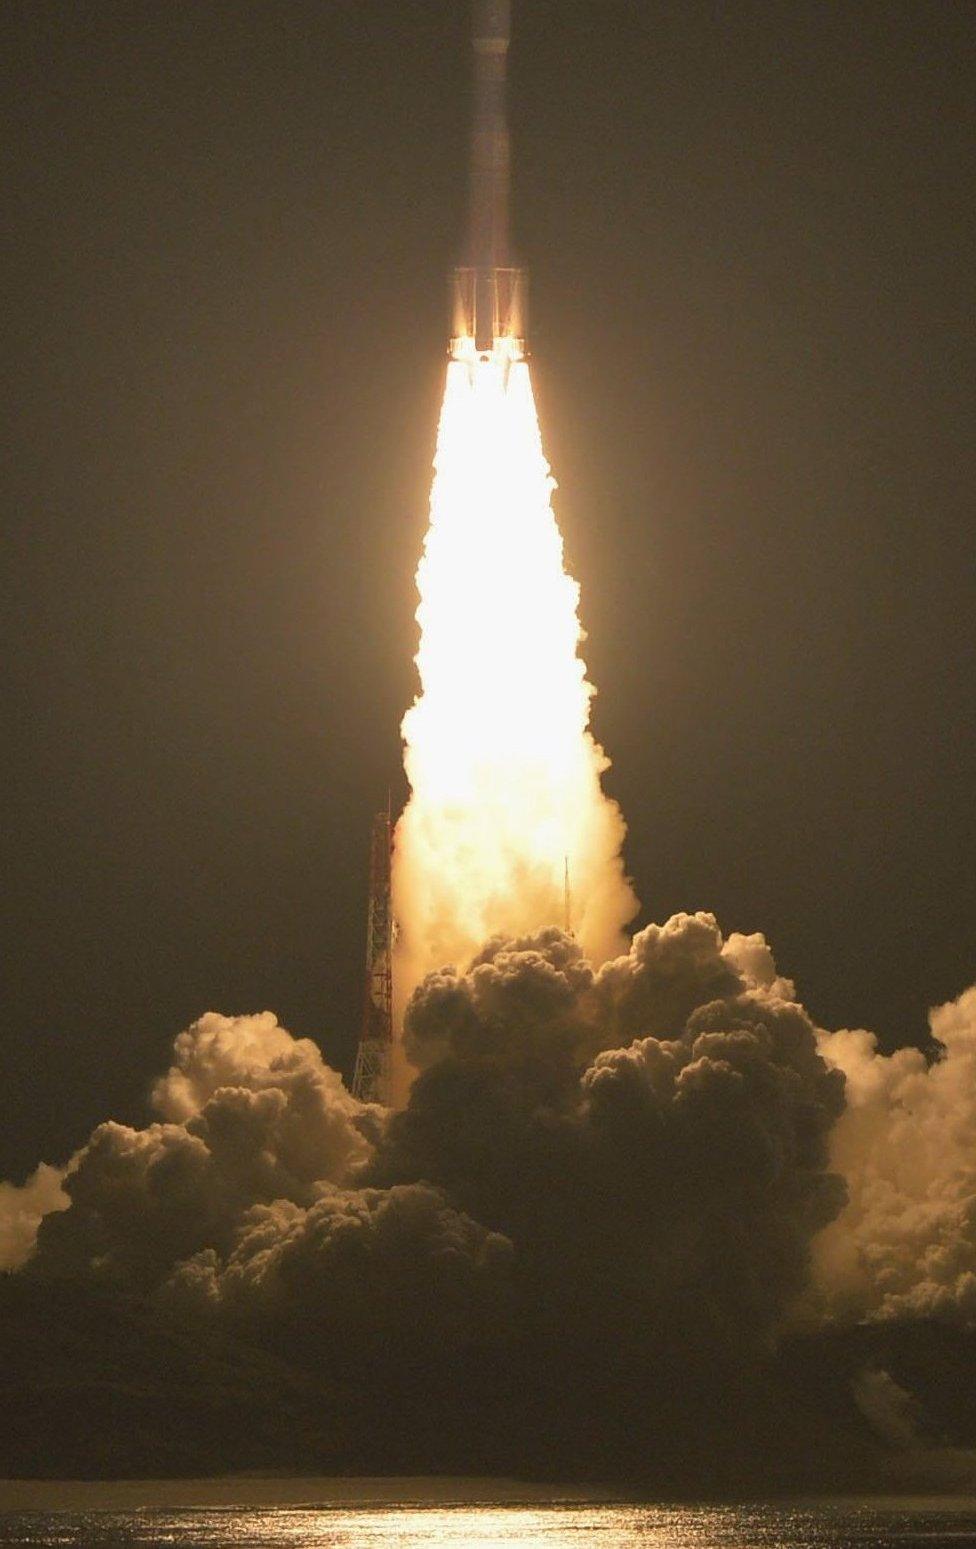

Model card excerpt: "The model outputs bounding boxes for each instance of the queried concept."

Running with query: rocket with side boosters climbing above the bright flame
[451,0,527,356]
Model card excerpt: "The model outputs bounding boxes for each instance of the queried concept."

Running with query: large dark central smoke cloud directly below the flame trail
[370,915,844,1360]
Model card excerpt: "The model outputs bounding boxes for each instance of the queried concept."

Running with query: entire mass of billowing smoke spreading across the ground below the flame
[0,914,976,1482]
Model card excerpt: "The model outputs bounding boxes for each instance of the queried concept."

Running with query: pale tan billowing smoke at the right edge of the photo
[815,987,976,1324]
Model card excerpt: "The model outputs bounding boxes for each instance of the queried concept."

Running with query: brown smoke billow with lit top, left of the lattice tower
[23,1011,376,1289]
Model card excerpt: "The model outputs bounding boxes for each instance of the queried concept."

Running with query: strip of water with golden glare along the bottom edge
[0,1501,976,1549]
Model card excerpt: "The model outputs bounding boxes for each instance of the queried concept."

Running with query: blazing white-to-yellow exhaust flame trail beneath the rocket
[393,338,637,1007]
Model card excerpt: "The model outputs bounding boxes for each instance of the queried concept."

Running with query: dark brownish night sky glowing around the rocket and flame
[0,0,976,1176]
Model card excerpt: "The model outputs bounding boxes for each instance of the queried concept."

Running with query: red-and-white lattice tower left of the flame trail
[352,805,393,1103]
